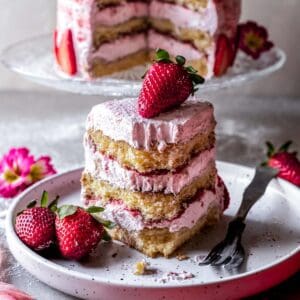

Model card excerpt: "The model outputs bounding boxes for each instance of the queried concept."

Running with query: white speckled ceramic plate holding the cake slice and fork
[6,162,300,300]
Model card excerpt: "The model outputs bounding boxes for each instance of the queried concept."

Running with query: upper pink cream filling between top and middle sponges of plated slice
[85,141,215,194]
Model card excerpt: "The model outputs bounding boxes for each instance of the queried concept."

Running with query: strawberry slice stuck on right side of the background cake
[214,34,235,76]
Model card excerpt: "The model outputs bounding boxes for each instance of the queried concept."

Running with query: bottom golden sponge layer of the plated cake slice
[109,205,222,257]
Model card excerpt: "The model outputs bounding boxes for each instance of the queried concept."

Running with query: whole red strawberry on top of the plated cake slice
[138,49,204,118]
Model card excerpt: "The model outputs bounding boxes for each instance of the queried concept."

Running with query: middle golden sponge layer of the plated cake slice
[81,162,217,221]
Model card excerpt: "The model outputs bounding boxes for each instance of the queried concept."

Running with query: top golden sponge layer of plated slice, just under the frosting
[88,127,215,173]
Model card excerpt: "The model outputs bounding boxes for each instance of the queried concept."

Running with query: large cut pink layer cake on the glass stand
[54,0,241,78]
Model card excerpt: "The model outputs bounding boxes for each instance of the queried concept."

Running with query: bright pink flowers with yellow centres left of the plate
[0,148,56,198]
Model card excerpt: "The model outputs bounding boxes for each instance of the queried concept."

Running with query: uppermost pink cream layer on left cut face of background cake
[93,2,148,26]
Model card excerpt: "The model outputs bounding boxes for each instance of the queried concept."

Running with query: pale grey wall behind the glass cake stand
[0,0,300,96]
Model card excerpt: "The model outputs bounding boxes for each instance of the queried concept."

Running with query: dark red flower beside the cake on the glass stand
[238,21,274,59]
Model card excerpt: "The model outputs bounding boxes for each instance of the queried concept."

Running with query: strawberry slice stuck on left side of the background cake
[54,29,77,75]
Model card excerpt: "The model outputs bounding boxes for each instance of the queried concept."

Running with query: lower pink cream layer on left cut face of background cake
[89,33,147,62]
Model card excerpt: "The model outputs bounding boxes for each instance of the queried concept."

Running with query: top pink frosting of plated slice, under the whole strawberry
[86,98,215,151]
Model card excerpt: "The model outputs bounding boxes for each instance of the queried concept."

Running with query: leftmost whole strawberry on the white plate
[15,192,57,251]
